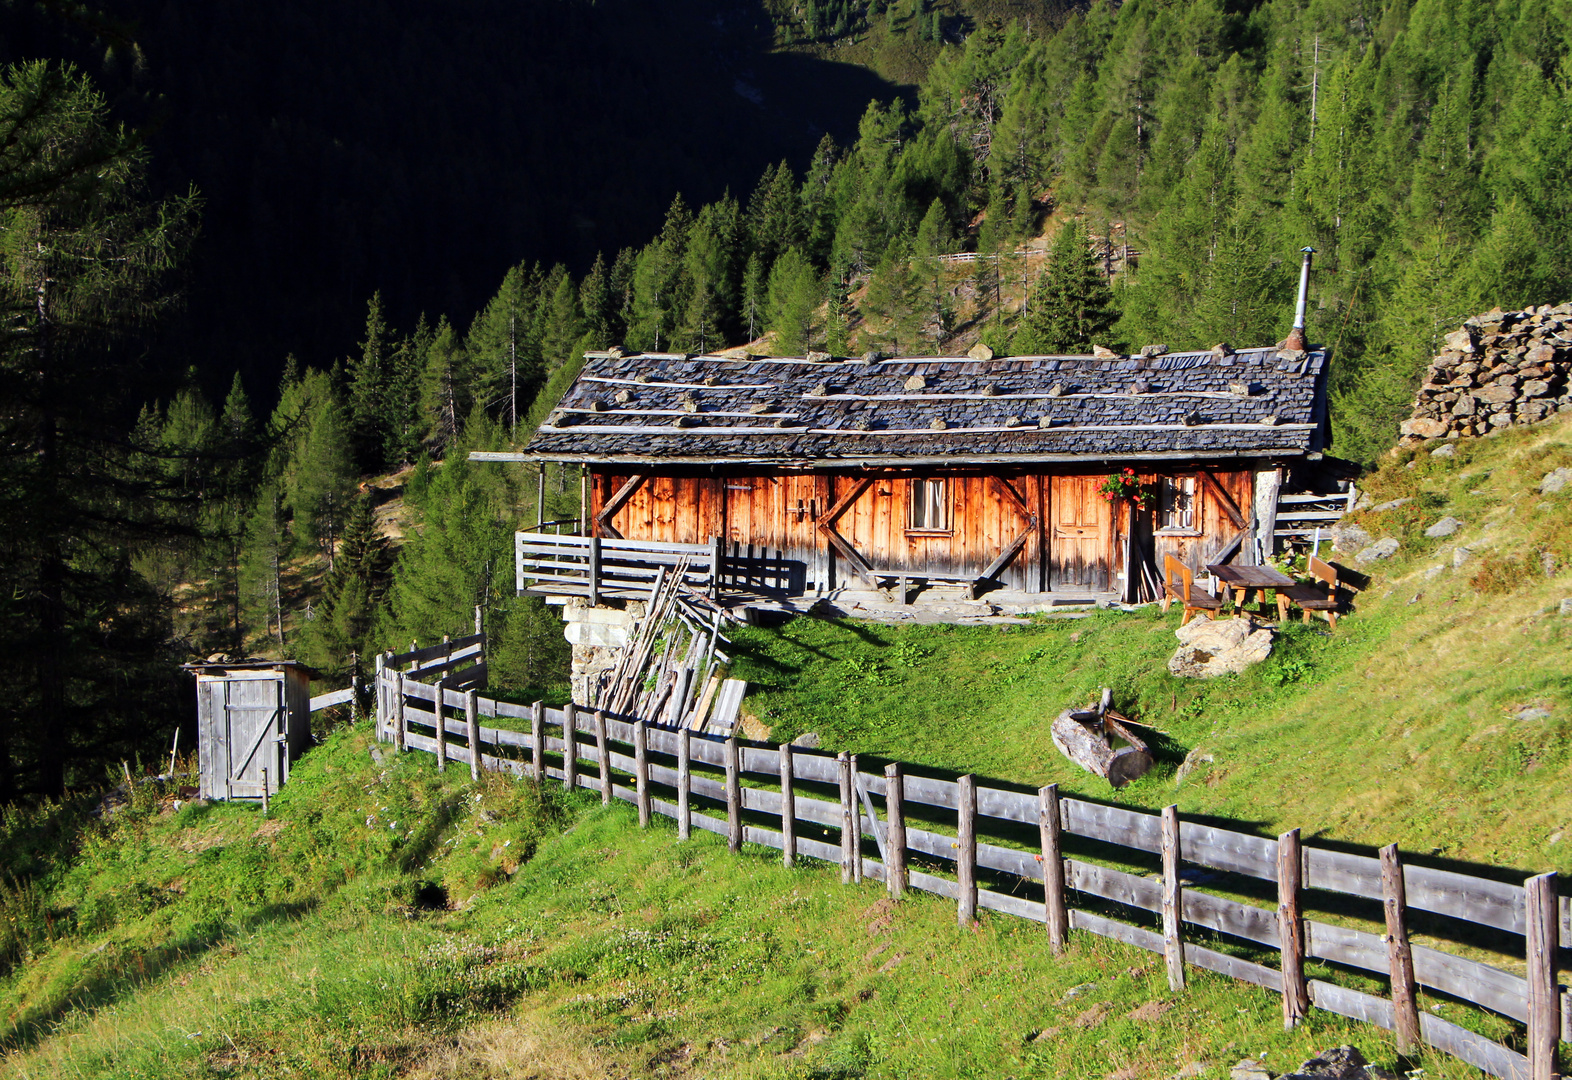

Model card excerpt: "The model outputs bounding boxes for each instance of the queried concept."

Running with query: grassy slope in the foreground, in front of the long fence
[0,728,1470,1080]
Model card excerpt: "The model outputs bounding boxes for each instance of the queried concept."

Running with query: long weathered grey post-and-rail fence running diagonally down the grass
[377,667,1572,1080]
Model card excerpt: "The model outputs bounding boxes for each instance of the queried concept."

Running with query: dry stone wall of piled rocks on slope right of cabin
[1401,303,1572,445]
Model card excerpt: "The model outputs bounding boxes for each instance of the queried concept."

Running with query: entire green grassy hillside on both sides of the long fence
[0,420,1572,1080]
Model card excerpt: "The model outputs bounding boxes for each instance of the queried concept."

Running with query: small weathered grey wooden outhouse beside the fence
[187,660,313,800]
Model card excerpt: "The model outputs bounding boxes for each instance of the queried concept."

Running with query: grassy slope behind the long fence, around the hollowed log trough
[736,421,1572,872]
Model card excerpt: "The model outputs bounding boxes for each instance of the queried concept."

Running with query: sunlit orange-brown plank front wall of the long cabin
[590,465,1254,596]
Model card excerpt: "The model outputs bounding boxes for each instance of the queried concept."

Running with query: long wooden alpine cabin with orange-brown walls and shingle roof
[486,346,1328,607]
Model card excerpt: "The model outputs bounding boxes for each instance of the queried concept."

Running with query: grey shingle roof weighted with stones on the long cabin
[525,347,1327,464]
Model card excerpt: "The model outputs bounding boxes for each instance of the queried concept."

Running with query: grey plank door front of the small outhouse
[206,674,288,799]
